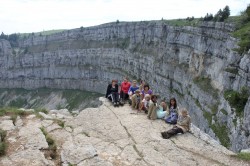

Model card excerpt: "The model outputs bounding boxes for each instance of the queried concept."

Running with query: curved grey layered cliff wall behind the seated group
[0,21,250,151]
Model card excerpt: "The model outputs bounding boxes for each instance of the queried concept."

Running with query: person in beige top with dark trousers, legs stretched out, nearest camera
[161,108,191,139]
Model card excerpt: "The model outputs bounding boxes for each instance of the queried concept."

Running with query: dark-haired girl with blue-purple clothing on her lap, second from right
[165,98,178,124]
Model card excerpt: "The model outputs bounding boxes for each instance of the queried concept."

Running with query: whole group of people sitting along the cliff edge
[106,77,191,139]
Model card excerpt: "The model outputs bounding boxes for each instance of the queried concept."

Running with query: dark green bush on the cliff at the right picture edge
[224,87,250,117]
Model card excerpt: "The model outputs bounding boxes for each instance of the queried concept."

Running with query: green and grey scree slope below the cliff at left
[0,88,103,111]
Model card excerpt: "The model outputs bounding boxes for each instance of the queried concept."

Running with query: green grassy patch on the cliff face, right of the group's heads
[193,77,218,99]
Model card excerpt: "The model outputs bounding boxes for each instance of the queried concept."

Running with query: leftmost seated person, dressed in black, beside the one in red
[106,80,119,106]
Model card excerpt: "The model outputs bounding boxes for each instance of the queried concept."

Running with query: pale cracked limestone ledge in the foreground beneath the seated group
[0,98,249,166]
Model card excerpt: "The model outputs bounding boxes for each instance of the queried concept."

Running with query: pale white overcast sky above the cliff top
[0,0,250,34]
